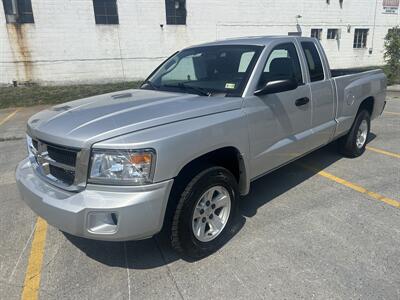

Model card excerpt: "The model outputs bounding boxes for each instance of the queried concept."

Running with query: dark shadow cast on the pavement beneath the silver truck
[64,133,376,269]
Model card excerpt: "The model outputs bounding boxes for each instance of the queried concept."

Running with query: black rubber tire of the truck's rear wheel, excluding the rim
[338,109,371,157]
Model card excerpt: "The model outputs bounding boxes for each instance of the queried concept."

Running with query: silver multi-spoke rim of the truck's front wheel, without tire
[192,186,231,242]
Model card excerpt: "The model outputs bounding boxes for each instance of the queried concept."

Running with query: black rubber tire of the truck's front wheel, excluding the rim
[171,166,239,259]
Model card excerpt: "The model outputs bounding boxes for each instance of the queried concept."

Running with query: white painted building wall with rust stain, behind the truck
[0,0,400,84]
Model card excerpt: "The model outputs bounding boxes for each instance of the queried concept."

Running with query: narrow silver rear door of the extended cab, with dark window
[300,40,336,148]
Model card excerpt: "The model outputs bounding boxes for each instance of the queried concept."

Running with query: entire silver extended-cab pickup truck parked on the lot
[16,36,386,258]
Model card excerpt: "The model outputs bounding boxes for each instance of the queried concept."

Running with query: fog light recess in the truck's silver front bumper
[87,211,118,234]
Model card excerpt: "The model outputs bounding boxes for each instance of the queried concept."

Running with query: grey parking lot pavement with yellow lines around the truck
[0,93,400,299]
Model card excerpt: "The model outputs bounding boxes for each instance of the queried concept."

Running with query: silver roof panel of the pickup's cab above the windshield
[188,35,315,48]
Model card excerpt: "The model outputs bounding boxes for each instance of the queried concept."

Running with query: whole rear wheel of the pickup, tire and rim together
[339,109,371,157]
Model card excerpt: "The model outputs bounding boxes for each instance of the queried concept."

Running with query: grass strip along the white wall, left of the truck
[0,82,140,108]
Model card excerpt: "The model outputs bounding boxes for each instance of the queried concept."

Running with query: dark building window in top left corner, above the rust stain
[3,0,35,23]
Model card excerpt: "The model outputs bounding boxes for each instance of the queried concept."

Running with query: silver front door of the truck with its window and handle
[244,40,311,178]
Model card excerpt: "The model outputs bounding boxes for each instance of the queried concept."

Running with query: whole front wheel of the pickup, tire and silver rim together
[171,167,239,258]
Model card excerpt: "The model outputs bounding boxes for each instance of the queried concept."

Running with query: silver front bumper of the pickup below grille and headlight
[15,159,173,241]
